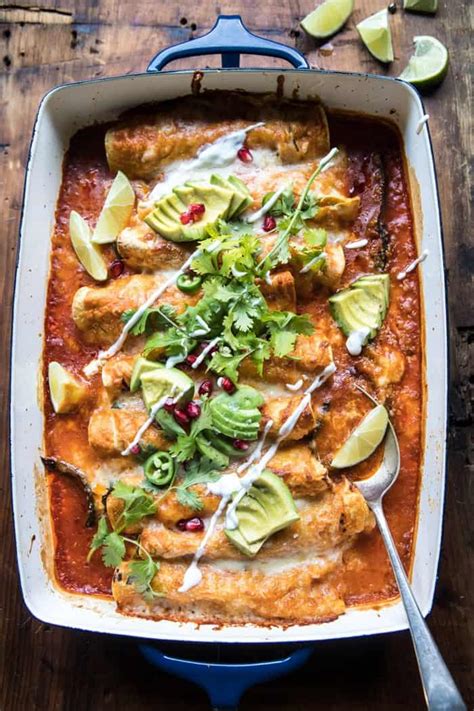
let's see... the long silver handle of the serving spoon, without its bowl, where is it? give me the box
[369,501,466,711]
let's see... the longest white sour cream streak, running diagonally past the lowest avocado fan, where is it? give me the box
[179,363,336,592]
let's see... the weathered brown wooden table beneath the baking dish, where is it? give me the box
[0,0,474,711]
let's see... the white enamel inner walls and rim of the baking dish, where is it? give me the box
[11,70,447,642]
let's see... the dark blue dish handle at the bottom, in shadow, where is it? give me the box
[140,644,313,711]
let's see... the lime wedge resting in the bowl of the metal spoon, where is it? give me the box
[331,405,388,469]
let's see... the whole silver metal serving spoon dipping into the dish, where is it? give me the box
[354,418,466,711]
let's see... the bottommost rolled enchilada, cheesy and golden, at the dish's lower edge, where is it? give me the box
[112,560,345,624]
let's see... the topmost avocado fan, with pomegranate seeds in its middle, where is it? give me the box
[145,175,252,242]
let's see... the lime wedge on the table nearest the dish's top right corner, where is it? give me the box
[400,35,448,89]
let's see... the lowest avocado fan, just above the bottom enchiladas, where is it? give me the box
[225,470,299,556]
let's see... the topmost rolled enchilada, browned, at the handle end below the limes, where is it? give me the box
[105,93,329,179]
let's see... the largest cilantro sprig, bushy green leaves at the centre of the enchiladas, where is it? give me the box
[144,231,313,382]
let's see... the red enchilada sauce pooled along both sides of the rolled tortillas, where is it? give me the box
[44,115,423,605]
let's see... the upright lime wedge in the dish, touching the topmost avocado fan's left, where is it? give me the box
[92,170,135,244]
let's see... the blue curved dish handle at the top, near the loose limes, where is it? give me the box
[147,15,309,72]
